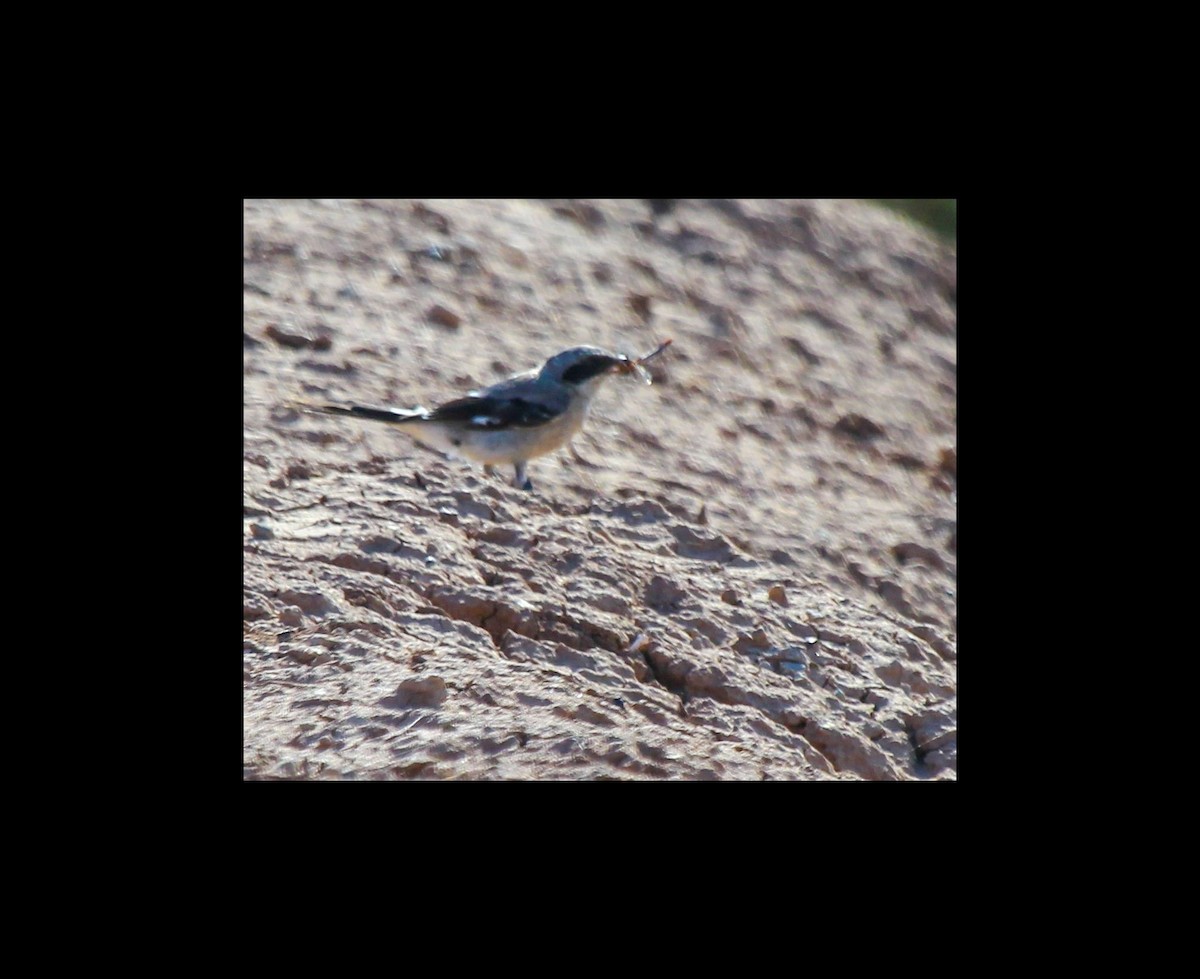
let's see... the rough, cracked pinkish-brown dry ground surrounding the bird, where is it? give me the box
[242,200,958,780]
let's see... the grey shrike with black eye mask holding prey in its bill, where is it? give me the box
[304,340,671,490]
